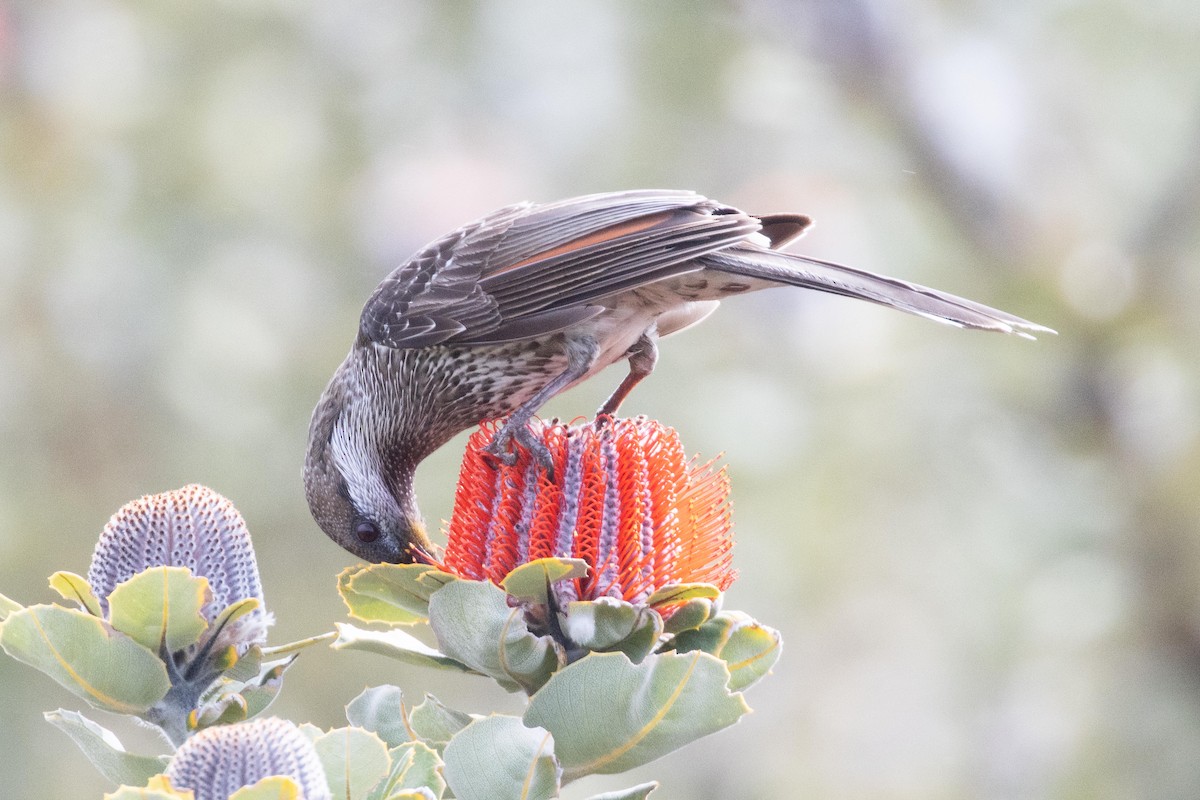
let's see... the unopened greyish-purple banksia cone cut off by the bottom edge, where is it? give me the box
[167,717,331,800]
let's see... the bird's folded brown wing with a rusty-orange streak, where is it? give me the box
[360,191,761,348]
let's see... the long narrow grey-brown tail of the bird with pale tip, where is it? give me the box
[701,247,1055,338]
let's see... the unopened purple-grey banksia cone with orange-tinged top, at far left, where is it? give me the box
[88,483,271,654]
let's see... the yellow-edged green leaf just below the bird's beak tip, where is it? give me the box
[337,564,455,625]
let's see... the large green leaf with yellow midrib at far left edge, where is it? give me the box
[0,606,170,714]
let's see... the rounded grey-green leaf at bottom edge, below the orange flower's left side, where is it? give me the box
[443,716,560,800]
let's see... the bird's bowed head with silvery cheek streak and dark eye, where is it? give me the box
[305,378,434,564]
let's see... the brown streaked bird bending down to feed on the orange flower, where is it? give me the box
[304,190,1054,564]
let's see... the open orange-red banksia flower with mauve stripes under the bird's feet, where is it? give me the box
[442,417,734,603]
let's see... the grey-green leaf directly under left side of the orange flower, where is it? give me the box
[430,581,558,691]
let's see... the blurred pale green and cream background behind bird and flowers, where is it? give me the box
[0,0,1200,800]
